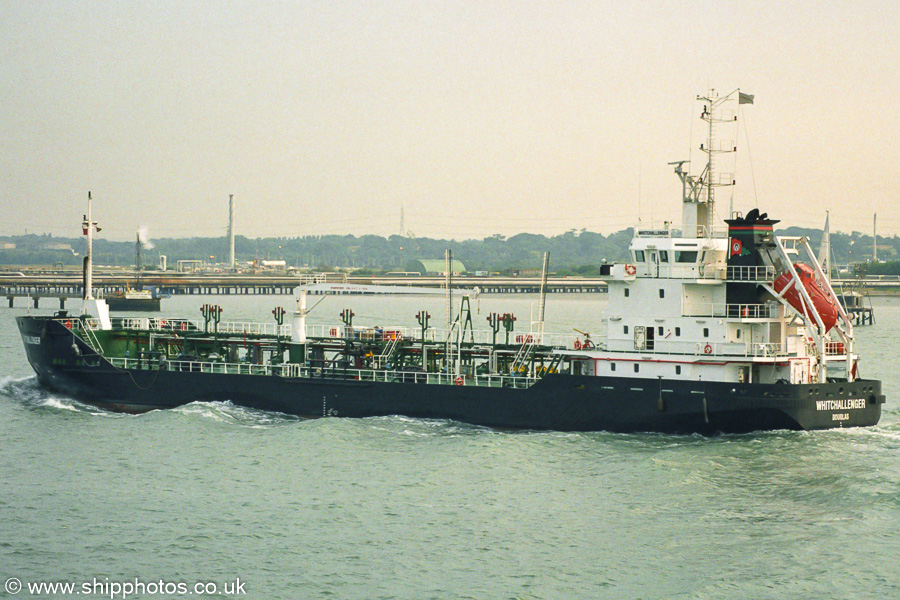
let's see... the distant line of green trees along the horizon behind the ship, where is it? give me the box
[0,227,900,275]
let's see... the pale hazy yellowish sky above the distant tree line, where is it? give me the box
[0,0,900,239]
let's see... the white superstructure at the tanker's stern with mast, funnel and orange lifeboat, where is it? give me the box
[567,90,857,383]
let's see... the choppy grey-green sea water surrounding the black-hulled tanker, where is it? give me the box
[0,295,900,600]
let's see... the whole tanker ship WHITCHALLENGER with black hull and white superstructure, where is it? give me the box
[17,90,885,434]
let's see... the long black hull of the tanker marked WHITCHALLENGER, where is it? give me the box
[17,317,884,434]
